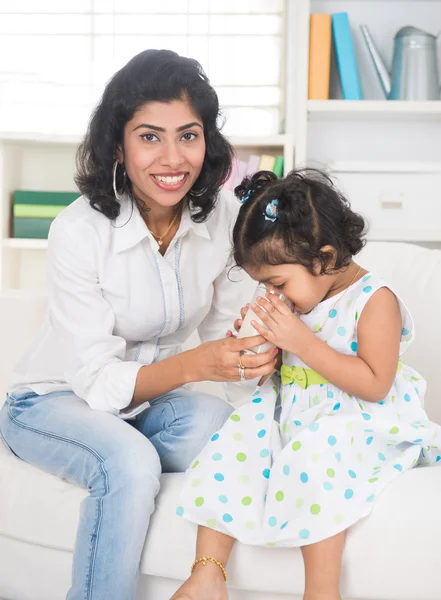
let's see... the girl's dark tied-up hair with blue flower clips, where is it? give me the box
[233,169,366,274]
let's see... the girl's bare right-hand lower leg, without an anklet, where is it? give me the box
[302,531,346,600]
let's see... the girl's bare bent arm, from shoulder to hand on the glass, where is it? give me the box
[249,288,402,402]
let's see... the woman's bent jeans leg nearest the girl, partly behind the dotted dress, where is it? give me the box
[134,388,233,473]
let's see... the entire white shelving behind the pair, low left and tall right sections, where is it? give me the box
[0,0,441,289]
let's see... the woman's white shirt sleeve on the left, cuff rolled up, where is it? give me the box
[47,219,148,418]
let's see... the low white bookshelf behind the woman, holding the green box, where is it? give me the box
[0,132,294,290]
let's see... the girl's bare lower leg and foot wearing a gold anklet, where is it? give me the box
[171,526,235,600]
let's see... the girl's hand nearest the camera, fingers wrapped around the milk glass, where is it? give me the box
[251,293,315,356]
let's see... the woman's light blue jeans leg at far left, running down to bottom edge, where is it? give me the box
[0,393,160,600]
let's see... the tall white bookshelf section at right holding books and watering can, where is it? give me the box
[290,0,441,247]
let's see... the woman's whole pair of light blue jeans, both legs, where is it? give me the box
[0,388,231,600]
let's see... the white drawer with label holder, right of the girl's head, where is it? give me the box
[328,163,441,242]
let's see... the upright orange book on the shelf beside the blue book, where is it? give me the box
[308,14,332,100]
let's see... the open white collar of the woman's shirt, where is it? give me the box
[112,194,211,252]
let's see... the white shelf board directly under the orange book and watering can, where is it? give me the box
[307,100,441,121]
